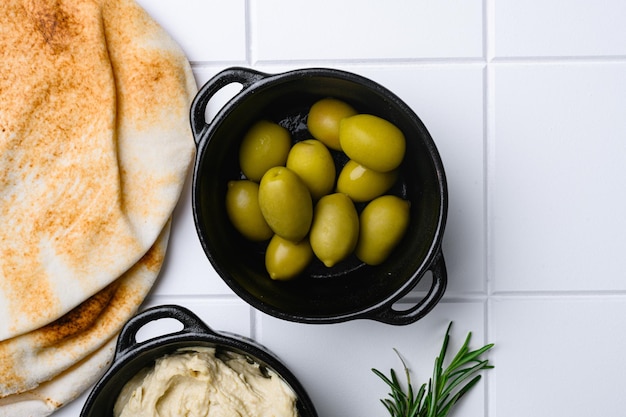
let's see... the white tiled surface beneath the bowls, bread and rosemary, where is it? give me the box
[18,0,626,417]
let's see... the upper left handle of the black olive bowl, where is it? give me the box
[190,67,269,144]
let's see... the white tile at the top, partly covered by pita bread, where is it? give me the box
[137,0,247,62]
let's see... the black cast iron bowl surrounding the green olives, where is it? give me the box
[191,67,448,325]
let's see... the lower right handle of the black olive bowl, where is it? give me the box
[367,249,448,325]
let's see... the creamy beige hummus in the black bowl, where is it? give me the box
[114,347,298,417]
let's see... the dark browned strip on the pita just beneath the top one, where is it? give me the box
[38,281,119,346]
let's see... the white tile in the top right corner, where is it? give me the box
[493,0,626,57]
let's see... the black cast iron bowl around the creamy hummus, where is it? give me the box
[80,305,317,417]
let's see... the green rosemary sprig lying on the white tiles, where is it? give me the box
[372,322,494,417]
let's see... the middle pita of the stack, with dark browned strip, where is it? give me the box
[0,223,170,400]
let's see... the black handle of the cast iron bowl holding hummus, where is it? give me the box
[114,305,216,361]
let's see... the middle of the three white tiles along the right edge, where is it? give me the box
[490,63,626,291]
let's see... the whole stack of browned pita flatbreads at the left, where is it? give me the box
[0,0,196,417]
